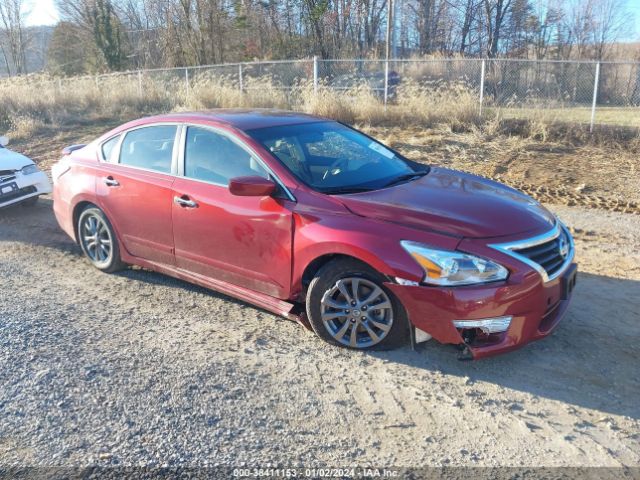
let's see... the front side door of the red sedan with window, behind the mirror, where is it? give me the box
[173,126,294,298]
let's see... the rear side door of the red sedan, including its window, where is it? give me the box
[96,124,178,265]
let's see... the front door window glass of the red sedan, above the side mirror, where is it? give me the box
[184,127,269,185]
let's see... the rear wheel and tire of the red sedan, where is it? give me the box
[78,207,125,273]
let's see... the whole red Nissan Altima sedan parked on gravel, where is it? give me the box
[52,110,576,359]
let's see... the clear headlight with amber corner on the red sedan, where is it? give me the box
[400,240,509,286]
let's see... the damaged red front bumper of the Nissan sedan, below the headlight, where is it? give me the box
[387,264,576,359]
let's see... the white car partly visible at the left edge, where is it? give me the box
[0,137,51,208]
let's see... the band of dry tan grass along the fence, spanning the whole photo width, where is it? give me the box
[0,75,640,144]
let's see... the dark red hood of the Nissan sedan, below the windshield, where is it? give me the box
[339,167,555,238]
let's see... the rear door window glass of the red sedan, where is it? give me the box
[120,125,177,173]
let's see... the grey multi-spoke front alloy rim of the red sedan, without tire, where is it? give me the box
[321,277,393,348]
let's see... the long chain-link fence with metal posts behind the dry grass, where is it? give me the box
[6,58,640,128]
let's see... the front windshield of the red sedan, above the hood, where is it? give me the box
[247,122,427,193]
